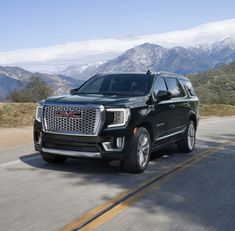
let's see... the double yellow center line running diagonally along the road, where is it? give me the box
[61,141,235,231]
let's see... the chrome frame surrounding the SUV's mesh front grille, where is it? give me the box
[42,103,105,137]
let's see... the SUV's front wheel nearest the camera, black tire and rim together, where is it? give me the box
[121,127,151,173]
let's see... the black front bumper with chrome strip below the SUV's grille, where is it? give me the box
[34,121,133,159]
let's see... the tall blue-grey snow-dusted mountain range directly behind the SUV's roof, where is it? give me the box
[61,37,235,80]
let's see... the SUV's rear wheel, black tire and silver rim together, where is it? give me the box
[178,120,196,153]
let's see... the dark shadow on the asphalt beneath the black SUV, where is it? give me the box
[20,134,231,177]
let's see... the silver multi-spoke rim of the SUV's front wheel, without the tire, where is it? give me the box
[137,133,150,168]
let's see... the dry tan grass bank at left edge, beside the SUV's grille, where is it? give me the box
[0,103,36,128]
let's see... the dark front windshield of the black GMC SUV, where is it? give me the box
[77,74,153,96]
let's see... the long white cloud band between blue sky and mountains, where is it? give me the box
[0,19,235,70]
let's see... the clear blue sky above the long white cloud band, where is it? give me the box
[0,0,235,51]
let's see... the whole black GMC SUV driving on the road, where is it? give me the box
[34,71,199,173]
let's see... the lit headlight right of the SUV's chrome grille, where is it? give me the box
[106,108,130,127]
